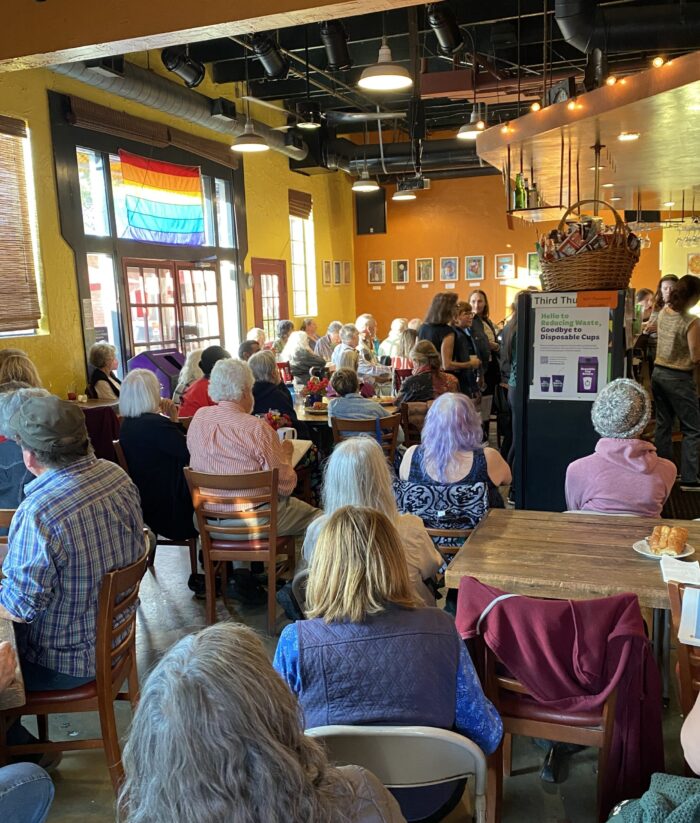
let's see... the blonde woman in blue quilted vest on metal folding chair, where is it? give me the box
[273,506,503,820]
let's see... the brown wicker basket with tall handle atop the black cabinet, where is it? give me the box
[540,200,639,291]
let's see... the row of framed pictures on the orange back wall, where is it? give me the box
[367,252,540,286]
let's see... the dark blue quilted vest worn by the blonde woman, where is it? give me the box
[296,608,462,729]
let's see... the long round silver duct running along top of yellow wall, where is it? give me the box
[52,63,308,160]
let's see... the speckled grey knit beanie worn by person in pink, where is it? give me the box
[591,377,651,439]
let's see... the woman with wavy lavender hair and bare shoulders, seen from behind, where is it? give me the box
[394,394,511,549]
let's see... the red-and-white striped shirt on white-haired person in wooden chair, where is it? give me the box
[187,400,297,511]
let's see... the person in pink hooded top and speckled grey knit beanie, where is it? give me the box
[565,378,676,517]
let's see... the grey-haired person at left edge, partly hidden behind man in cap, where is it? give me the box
[0,381,48,534]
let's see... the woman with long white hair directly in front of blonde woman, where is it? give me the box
[302,437,442,606]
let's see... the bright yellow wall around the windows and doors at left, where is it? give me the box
[0,62,355,395]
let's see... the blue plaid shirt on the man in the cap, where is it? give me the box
[0,456,145,677]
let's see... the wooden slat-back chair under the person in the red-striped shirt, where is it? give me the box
[185,468,295,634]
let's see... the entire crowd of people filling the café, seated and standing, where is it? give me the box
[0,282,700,823]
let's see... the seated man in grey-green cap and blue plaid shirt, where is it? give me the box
[0,395,145,691]
